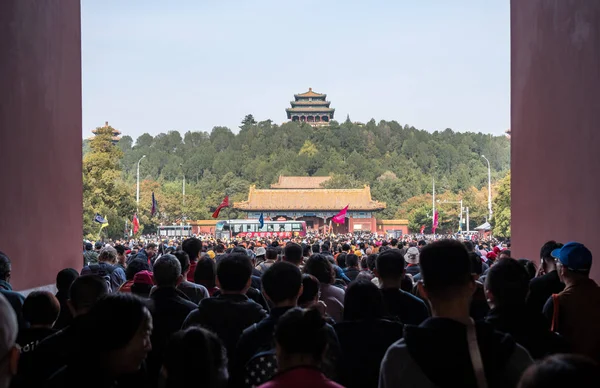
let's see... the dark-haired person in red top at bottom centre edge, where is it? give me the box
[260,307,341,388]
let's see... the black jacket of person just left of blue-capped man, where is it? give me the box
[485,306,568,359]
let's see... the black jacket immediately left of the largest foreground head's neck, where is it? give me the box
[381,288,429,325]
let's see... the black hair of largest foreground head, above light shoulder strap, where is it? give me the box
[418,240,473,294]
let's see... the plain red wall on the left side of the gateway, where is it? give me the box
[0,0,82,290]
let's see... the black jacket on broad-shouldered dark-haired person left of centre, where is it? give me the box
[183,294,267,359]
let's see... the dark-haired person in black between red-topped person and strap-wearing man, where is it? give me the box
[334,280,404,388]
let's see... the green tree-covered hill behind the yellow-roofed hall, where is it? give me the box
[84,115,510,234]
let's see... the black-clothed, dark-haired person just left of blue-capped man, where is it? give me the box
[485,259,568,359]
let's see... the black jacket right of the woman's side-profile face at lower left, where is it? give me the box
[147,287,197,379]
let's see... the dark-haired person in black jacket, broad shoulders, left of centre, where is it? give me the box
[182,252,267,357]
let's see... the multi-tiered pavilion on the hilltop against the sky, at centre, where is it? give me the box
[285,88,335,126]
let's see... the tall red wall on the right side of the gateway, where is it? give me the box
[511,0,600,280]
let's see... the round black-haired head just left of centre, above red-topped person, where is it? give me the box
[261,261,302,303]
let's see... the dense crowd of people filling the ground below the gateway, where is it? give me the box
[0,235,600,388]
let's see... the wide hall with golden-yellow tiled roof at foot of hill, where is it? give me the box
[233,176,385,233]
